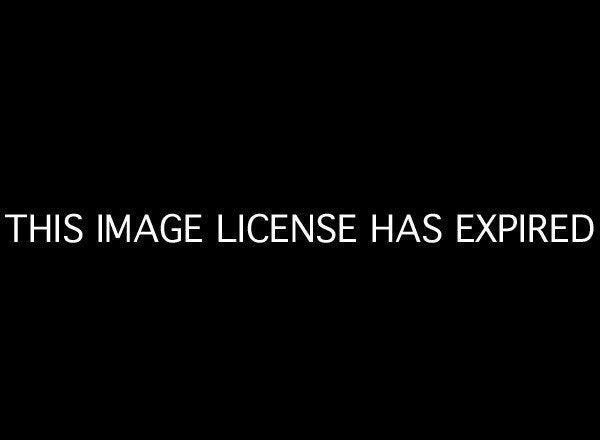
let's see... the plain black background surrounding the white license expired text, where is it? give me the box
[1,5,598,433]
